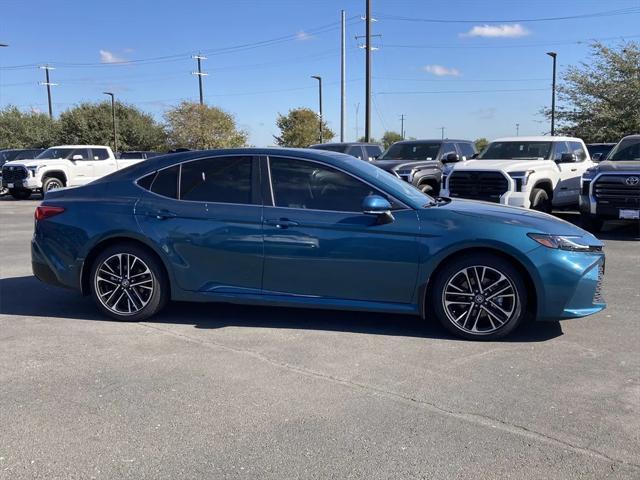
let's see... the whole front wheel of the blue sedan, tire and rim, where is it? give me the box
[431,253,527,340]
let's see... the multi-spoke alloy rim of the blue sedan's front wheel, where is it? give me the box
[442,265,519,335]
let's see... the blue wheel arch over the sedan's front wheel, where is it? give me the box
[419,245,540,318]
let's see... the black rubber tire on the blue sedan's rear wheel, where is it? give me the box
[89,243,170,322]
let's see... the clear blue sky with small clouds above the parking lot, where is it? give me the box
[0,0,640,145]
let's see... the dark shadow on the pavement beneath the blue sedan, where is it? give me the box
[0,276,562,342]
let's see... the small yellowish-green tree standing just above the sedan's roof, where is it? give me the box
[273,108,335,148]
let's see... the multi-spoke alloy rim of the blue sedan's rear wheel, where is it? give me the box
[94,253,156,316]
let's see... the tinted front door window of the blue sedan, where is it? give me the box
[269,157,379,212]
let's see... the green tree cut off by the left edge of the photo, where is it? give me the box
[0,106,58,148]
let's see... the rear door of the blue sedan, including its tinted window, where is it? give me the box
[136,155,263,295]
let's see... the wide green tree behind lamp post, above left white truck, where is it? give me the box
[57,101,166,151]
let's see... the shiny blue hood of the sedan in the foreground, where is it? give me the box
[420,199,602,246]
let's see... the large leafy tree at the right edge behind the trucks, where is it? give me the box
[543,42,640,143]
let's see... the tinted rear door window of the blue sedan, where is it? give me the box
[180,157,252,204]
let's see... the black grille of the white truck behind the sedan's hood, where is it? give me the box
[449,170,509,202]
